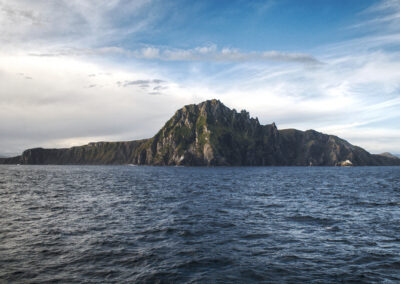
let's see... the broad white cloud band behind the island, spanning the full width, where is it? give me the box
[0,43,400,155]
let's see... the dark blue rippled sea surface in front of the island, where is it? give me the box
[0,166,400,283]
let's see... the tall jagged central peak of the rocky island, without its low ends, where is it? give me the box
[138,100,281,166]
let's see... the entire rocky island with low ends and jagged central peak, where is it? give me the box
[0,100,400,166]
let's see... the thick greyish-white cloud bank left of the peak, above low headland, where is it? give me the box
[0,53,193,153]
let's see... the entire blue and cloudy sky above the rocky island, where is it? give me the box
[0,0,400,156]
